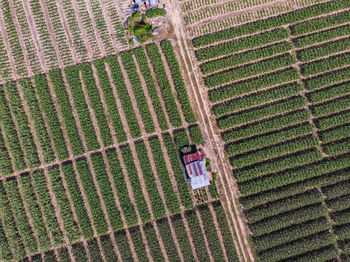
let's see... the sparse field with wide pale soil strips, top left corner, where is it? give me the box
[0,0,128,83]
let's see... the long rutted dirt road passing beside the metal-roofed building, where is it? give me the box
[166,0,254,261]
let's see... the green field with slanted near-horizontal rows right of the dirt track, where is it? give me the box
[190,0,350,262]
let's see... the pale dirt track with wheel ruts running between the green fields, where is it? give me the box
[167,0,254,261]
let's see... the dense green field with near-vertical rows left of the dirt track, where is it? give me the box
[0,35,237,262]
